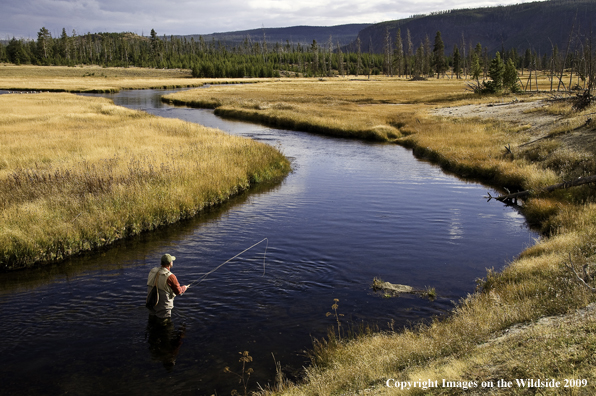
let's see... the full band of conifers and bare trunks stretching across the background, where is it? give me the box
[0,27,596,92]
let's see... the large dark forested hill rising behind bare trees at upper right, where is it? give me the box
[348,0,596,54]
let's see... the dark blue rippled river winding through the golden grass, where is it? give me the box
[0,90,537,395]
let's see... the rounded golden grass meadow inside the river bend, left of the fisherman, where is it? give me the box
[0,93,289,269]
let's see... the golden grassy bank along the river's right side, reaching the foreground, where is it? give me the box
[167,79,596,395]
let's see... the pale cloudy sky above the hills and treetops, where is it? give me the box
[0,0,526,40]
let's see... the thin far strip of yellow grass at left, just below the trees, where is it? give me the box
[0,64,262,93]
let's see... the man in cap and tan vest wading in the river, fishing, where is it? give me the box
[147,254,188,320]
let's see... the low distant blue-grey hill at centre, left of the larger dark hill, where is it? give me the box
[180,24,370,47]
